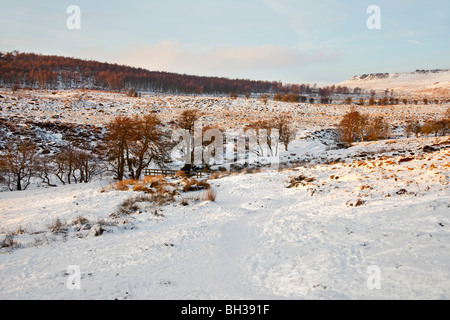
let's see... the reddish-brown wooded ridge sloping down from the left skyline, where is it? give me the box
[0,51,289,94]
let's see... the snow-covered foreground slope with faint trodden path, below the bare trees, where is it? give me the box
[0,133,450,299]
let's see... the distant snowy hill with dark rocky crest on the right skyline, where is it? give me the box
[339,69,450,96]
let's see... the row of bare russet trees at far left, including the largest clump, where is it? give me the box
[0,114,178,191]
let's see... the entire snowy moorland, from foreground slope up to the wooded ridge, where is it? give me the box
[0,88,450,299]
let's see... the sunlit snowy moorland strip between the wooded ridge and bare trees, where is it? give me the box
[0,89,449,130]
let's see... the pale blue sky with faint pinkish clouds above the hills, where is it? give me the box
[0,0,450,85]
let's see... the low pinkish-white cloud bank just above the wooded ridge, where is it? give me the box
[79,40,339,78]
